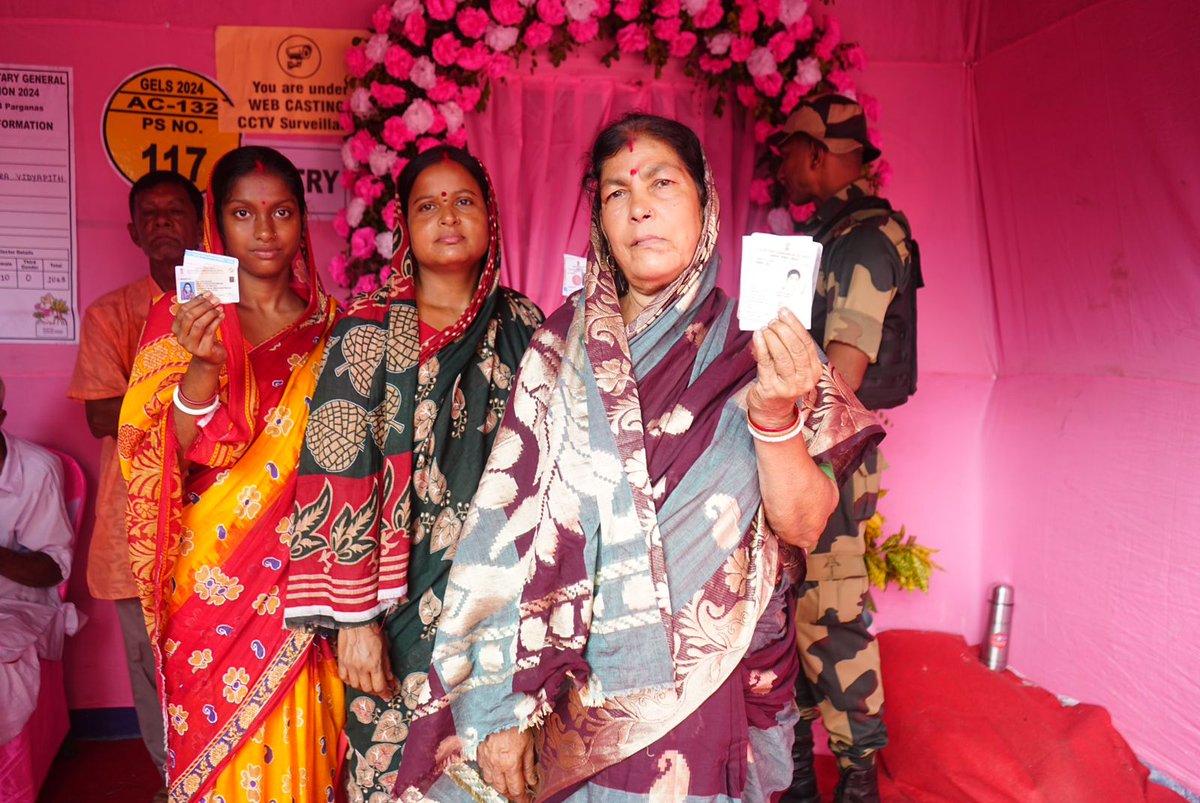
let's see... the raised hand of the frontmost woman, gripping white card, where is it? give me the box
[746,308,822,429]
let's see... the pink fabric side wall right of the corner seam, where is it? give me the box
[976,0,1200,789]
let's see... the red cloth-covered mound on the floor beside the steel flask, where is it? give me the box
[868,630,1183,803]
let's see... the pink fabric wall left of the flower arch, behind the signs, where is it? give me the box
[0,17,350,708]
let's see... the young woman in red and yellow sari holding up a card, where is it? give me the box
[118,148,344,803]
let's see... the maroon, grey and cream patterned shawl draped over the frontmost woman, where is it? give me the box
[396,160,882,801]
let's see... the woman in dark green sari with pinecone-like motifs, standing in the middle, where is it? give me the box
[284,146,541,803]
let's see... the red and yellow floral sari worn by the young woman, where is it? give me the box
[118,205,344,803]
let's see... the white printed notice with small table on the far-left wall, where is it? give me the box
[0,65,78,343]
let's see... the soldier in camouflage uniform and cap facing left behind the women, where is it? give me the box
[772,95,919,803]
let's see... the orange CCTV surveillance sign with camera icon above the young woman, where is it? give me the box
[216,25,367,137]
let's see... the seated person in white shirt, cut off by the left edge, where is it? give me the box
[0,379,80,745]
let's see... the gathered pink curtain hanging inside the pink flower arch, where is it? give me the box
[467,48,754,312]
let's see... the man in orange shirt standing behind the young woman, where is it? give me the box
[67,170,204,787]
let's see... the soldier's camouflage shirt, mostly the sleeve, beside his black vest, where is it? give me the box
[803,180,908,362]
